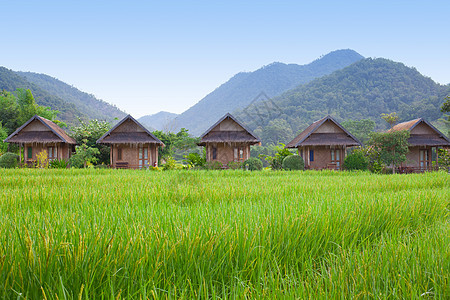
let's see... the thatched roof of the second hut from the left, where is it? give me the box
[97,115,164,146]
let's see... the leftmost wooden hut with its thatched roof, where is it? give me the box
[5,115,77,165]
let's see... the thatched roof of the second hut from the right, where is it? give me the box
[286,116,362,148]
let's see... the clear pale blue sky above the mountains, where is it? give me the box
[0,0,450,117]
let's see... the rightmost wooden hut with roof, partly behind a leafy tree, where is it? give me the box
[389,118,450,171]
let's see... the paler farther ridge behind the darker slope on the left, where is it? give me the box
[17,72,126,121]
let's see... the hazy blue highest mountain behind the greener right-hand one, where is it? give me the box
[167,50,363,135]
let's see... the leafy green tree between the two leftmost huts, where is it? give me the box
[71,119,111,165]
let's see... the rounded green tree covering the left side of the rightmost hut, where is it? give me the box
[369,130,410,173]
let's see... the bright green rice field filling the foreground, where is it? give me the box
[0,169,450,299]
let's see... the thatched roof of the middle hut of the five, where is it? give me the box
[198,113,261,146]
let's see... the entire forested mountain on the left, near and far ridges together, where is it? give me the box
[0,67,126,125]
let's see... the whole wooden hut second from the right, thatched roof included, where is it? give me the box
[286,116,362,170]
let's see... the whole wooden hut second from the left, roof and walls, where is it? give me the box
[97,115,164,169]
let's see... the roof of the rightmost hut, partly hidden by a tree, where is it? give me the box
[388,118,450,147]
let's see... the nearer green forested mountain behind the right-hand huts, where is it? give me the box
[237,58,450,143]
